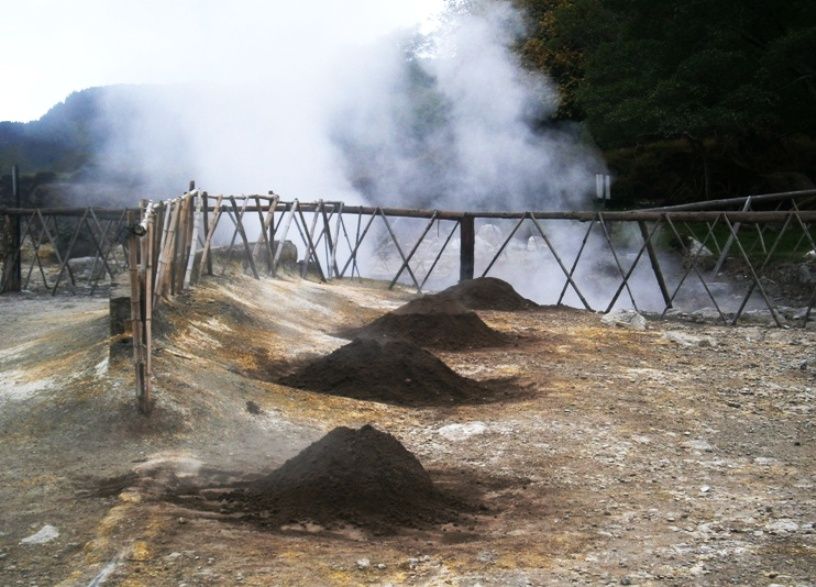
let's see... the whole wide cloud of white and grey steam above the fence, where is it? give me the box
[91,3,603,209]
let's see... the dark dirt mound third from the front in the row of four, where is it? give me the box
[342,296,508,350]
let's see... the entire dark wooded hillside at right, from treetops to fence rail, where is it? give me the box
[516,0,816,201]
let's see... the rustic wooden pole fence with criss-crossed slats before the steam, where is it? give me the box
[0,185,816,413]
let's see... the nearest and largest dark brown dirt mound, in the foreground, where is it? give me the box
[223,426,455,532]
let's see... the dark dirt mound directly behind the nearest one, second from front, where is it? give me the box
[280,338,485,406]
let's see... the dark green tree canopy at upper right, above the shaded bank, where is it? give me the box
[517,0,816,147]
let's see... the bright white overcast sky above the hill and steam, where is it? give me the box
[0,0,444,121]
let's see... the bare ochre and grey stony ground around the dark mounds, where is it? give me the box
[0,278,816,586]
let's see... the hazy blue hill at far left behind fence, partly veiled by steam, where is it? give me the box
[0,85,192,206]
